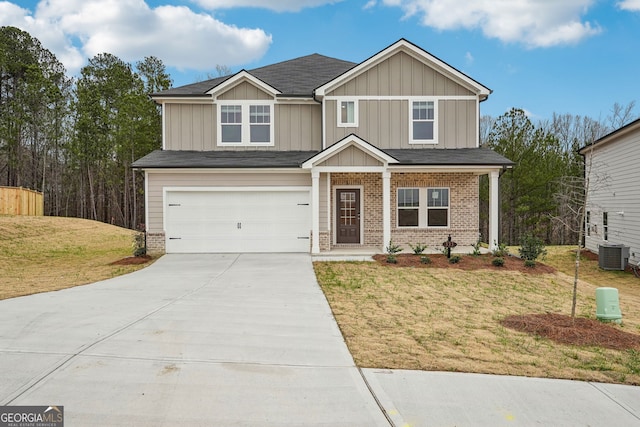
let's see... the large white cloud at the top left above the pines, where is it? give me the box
[0,0,271,74]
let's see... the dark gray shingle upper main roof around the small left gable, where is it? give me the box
[152,53,357,96]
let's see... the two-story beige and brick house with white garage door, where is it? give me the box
[133,39,512,253]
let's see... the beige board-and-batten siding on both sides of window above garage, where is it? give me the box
[164,103,322,151]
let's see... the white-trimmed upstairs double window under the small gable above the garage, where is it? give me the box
[218,101,274,145]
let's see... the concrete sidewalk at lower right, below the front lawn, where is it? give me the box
[363,369,640,427]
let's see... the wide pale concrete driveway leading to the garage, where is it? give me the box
[0,254,389,426]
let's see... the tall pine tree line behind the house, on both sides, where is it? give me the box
[0,27,635,245]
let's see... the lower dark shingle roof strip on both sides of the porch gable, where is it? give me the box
[132,148,513,169]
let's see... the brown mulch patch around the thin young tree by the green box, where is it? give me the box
[501,313,640,350]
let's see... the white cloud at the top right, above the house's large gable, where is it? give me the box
[383,0,604,47]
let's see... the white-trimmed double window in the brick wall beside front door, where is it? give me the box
[397,187,450,228]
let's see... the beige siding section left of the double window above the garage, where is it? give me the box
[164,104,215,151]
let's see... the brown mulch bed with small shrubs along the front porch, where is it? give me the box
[373,254,556,274]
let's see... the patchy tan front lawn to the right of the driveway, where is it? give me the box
[314,247,640,385]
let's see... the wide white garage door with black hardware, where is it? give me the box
[165,189,311,253]
